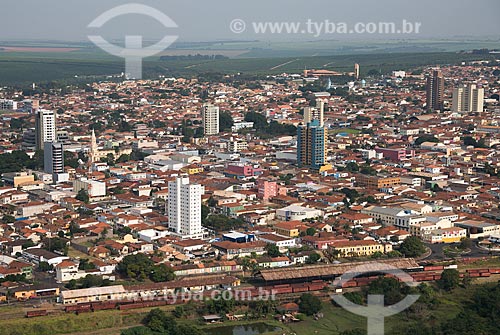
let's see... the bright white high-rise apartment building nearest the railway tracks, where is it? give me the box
[167,175,205,239]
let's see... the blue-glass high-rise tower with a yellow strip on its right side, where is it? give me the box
[297,119,328,170]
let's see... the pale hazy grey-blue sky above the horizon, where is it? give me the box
[0,0,500,41]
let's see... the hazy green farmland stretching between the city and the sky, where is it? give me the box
[0,42,500,87]
